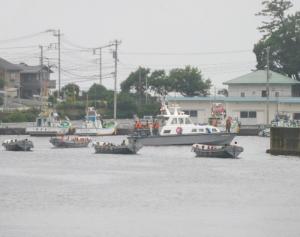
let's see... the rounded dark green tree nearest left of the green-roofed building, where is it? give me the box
[169,66,211,96]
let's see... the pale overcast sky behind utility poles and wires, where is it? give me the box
[0,0,300,89]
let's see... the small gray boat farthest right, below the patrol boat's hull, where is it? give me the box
[192,144,244,158]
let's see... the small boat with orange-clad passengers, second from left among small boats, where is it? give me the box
[50,136,91,148]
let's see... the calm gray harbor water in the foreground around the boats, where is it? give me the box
[0,136,300,237]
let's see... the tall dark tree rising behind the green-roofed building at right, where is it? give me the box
[253,0,300,80]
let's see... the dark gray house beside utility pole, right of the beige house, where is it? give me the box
[19,63,56,99]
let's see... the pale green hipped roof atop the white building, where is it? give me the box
[223,70,300,85]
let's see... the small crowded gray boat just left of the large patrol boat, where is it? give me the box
[94,139,143,154]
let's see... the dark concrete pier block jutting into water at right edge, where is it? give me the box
[269,127,300,156]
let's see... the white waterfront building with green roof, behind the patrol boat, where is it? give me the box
[167,70,300,125]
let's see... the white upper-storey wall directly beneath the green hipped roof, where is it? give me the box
[228,84,292,97]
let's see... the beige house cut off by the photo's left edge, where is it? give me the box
[0,58,22,98]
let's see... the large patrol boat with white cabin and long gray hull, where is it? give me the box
[128,103,236,146]
